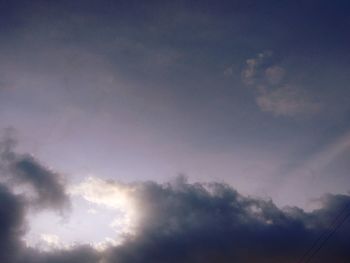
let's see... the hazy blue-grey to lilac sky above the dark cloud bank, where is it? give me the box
[0,0,350,262]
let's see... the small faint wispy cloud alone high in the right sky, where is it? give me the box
[242,51,321,117]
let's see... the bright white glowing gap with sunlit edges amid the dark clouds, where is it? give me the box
[25,177,137,251]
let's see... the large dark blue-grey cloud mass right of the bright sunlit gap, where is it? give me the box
[100,179,350,263]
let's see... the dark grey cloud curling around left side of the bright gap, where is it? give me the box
[0,134,99,263]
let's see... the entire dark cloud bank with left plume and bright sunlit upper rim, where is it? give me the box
[0,136,350,263]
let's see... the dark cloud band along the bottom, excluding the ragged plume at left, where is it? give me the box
[0,165,350,263]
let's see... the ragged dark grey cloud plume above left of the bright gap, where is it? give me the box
[0,135,69,211]
